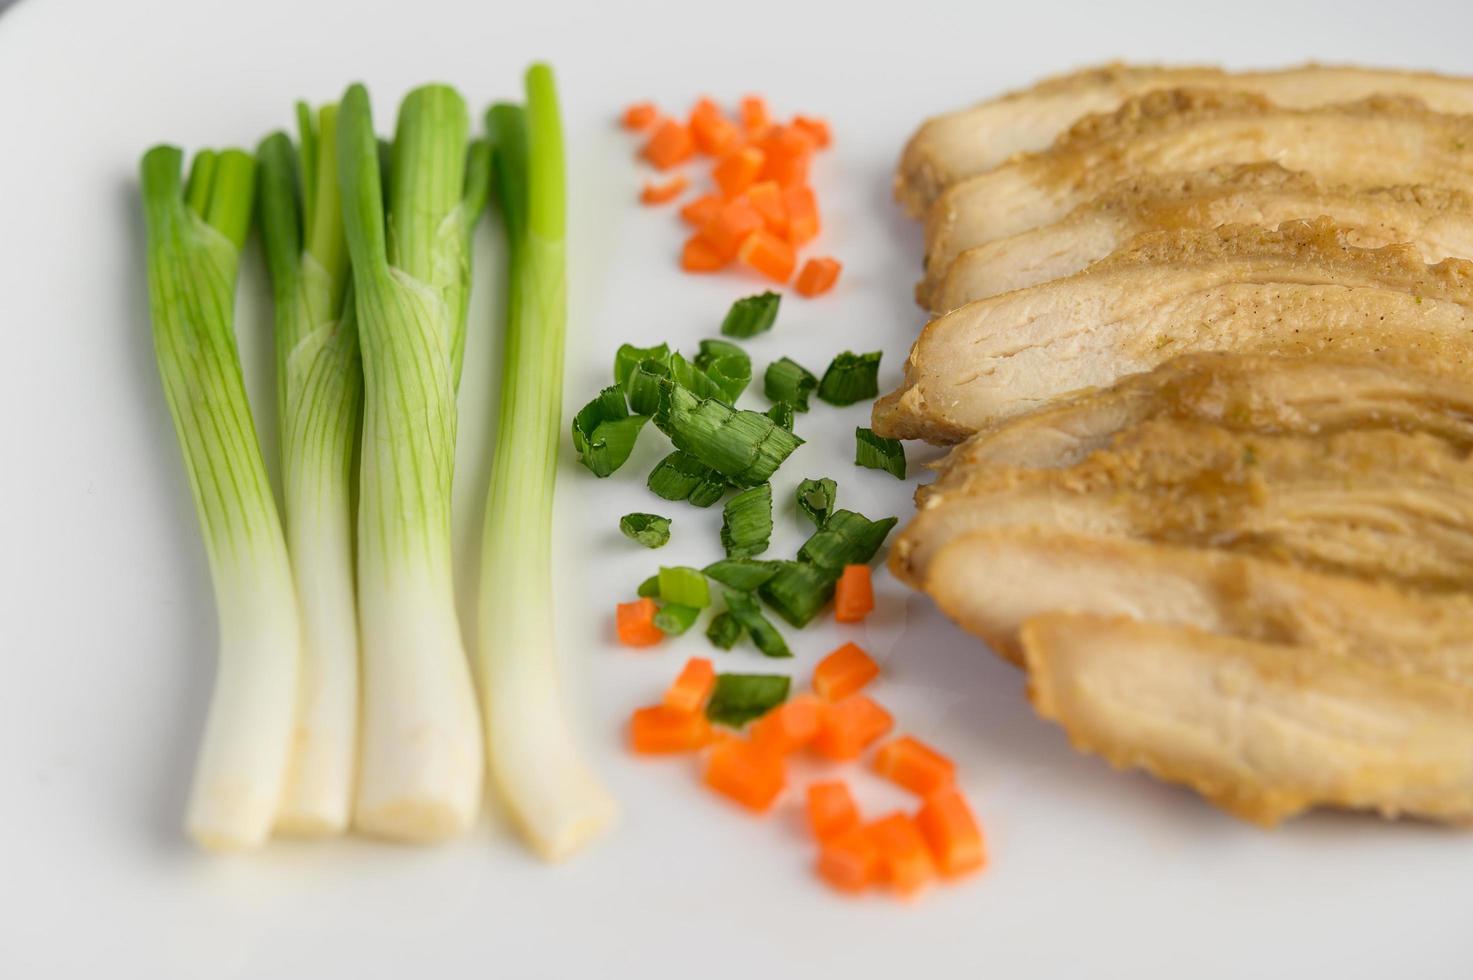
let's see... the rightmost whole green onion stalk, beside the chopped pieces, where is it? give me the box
[477,65,617,859]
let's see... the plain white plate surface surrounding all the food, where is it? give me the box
[0,0,1473,980]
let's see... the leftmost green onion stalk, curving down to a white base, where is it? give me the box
[140,146,300,847]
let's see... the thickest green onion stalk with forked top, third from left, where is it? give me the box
[337,85,489,840]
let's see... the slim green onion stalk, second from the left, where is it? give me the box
[256,105,362,836]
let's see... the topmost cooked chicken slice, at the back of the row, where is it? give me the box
[896,65,1473,218]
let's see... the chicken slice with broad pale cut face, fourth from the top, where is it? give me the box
[873,220,1473,442]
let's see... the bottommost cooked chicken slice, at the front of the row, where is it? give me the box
[1022,613,1473,827]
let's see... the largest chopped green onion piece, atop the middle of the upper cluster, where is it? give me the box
[666,385,803,486]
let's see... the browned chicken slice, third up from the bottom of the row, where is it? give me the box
[891,419,1473,592]
